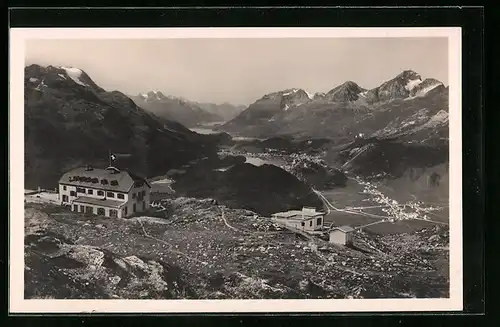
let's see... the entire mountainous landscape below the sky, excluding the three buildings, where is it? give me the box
[25,65,449,299]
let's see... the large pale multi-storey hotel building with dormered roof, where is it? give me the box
[59,167,151,218]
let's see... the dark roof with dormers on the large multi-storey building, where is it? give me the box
[59,167,151,192]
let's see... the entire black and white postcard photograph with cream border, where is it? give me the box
[10,28,462,312]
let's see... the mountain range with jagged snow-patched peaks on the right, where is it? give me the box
[219,70,448,141]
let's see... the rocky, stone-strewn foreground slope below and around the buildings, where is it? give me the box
[25,202,449,299]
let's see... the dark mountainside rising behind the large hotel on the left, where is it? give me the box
[24,65,214,187]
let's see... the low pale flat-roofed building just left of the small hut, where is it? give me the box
[271,207,325,231]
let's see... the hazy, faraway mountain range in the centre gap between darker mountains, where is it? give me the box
[130,91,244,127]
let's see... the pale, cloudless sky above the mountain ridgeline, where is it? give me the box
[25,37,448,105]
